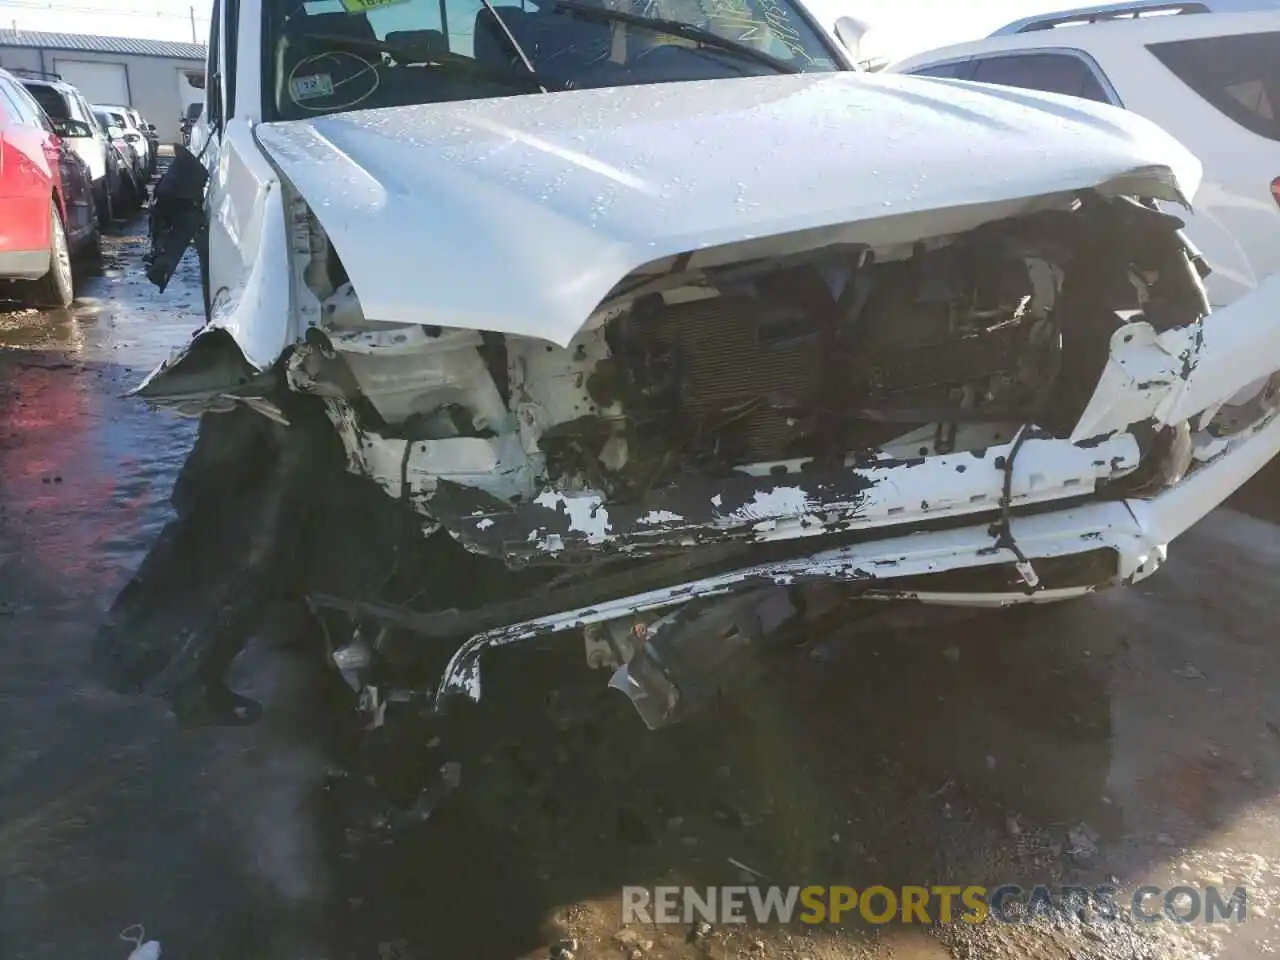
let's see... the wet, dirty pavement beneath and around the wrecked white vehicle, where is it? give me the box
[0,220,1280,960]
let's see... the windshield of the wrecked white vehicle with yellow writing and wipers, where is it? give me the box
[268,0,840,119]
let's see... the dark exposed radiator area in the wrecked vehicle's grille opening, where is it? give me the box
[544,227,1062,498]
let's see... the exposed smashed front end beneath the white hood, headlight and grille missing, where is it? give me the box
[289,193,1208,562]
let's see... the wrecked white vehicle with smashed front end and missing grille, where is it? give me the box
[120,0,1280,742]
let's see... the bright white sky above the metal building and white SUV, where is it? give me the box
[0,0,1074,59]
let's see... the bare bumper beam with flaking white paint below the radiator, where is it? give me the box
[431,434,1140,559]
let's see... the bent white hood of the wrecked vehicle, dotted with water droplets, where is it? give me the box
[256,73,1201,344]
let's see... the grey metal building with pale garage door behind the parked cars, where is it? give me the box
[0,29,205,143]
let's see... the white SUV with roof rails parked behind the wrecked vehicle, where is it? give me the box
[888,0,1280,306]
